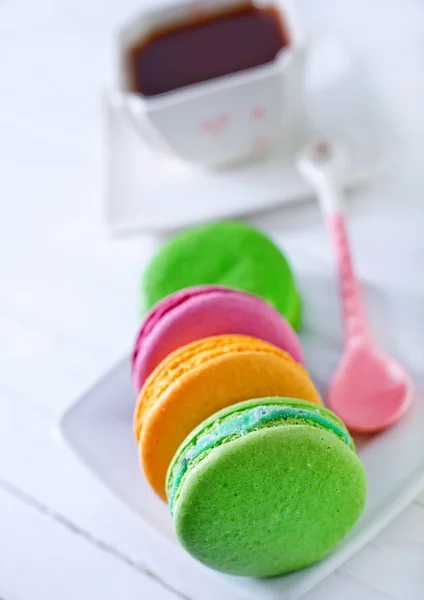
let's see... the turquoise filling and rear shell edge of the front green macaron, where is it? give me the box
[167,399,353,514]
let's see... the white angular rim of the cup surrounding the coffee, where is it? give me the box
[118,0,306,108]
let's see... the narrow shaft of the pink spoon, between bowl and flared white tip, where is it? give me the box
[317,176,369,346]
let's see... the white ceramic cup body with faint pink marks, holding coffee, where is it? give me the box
[118,0,306,167]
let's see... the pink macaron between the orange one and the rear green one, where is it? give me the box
[132,285,304,392]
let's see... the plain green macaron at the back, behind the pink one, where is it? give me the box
[141,221,301,329]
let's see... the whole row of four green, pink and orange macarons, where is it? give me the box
[132,223,366,577]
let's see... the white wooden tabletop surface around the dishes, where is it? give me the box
[0,0,424,600]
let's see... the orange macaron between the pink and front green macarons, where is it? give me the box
[134,335,321,499]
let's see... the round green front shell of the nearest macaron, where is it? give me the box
[174,425,366,577]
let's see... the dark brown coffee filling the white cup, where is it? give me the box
[125,2,290,96]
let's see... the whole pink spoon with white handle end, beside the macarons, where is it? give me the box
[299,142,413,433]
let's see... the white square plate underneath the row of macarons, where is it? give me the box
[59,275,424,600]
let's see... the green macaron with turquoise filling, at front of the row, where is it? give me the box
[167,398,366,577]
